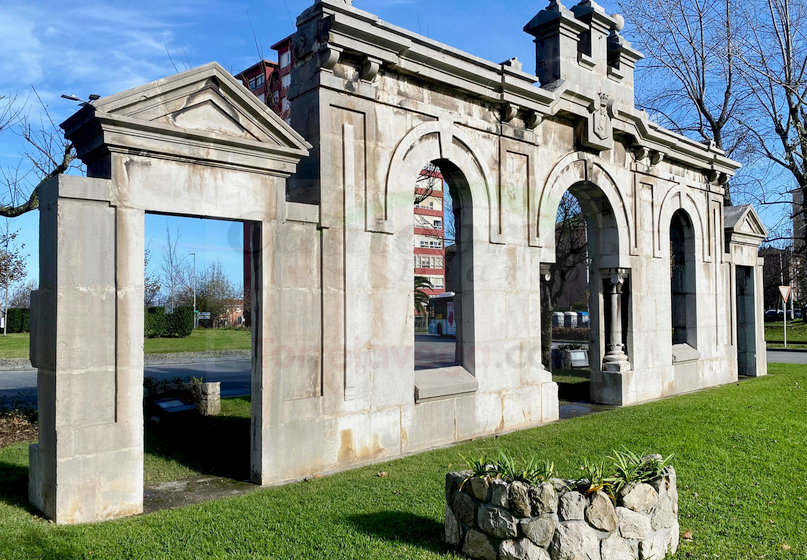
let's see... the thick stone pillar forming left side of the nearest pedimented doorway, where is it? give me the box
[28,175,144,524]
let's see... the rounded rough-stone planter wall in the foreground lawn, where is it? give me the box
[445,466,679,560]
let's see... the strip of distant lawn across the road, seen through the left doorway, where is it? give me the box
[0,329,252,358]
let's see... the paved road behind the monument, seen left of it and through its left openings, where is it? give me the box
[0,334,456,402]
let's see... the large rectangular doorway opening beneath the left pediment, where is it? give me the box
[143,214,254,490]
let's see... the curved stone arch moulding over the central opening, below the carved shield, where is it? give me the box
[536,152,634,267]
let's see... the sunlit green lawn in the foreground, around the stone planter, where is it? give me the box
[0,365,807,560]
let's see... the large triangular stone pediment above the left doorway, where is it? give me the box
[62,62,309,155]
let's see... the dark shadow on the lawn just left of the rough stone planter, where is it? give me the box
[348,511,446,553]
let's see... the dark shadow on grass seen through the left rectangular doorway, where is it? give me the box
[145,397,250,480]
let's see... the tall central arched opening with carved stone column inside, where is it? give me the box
[541,181,630,402]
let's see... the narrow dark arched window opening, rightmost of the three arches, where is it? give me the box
[670,210,698,348]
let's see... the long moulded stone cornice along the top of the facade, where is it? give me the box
[297,0,740,176]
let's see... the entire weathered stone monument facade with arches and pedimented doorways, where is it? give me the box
[30,0,766,523]
